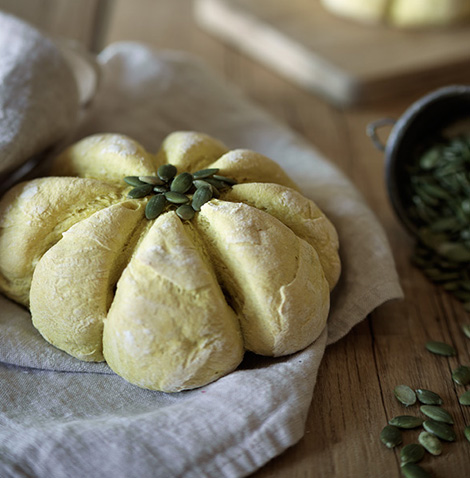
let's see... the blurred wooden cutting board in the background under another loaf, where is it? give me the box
[194,0,470,105]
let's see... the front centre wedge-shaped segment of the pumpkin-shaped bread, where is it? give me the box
[103,212,244,392]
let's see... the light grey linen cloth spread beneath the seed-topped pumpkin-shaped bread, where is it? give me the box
[0,14,402,478]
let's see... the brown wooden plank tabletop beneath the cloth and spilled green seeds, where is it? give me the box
[4,0,470,478]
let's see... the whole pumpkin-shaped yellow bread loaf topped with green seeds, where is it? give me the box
[0,132,340,392]
